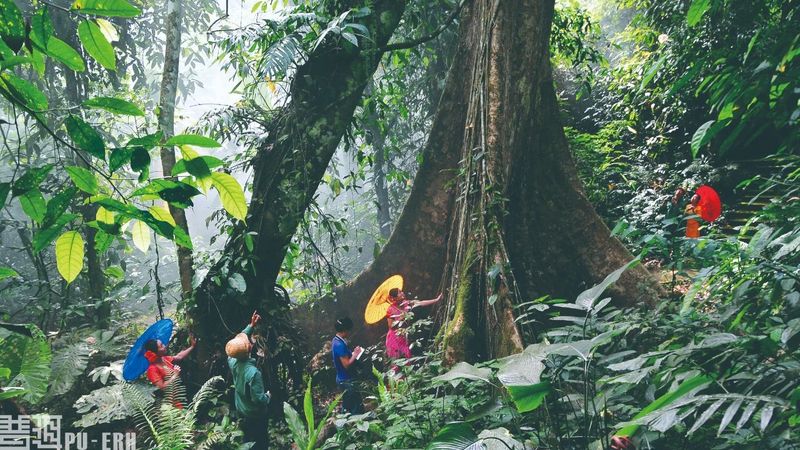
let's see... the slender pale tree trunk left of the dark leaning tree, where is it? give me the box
[158,0,194,298]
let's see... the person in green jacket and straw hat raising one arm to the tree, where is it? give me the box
[225,311,270,450]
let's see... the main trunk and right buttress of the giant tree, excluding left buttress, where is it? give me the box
[444,0,659,362]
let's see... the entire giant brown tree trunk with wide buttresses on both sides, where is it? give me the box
[298,0,658,361]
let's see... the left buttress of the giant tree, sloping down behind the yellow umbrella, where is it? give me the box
[293,5,476,349]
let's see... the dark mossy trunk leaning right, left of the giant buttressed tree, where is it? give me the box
[188,0,405,405]
